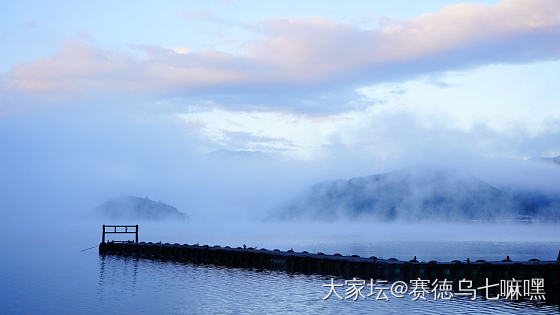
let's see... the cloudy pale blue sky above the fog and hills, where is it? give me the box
[0,0,560,222]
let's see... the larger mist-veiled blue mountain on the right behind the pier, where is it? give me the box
[274,169,558,221]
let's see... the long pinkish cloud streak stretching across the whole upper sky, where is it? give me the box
[0,0,560,108]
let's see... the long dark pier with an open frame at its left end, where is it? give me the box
[99,226,560,301]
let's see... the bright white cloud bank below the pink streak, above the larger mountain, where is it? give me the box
[180,62,560,160]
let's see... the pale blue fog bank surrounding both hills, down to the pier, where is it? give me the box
[0,108,560,249]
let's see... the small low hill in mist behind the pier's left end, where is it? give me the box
[94,196,188,221]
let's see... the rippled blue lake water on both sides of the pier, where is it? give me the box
[0,238,560,314]
